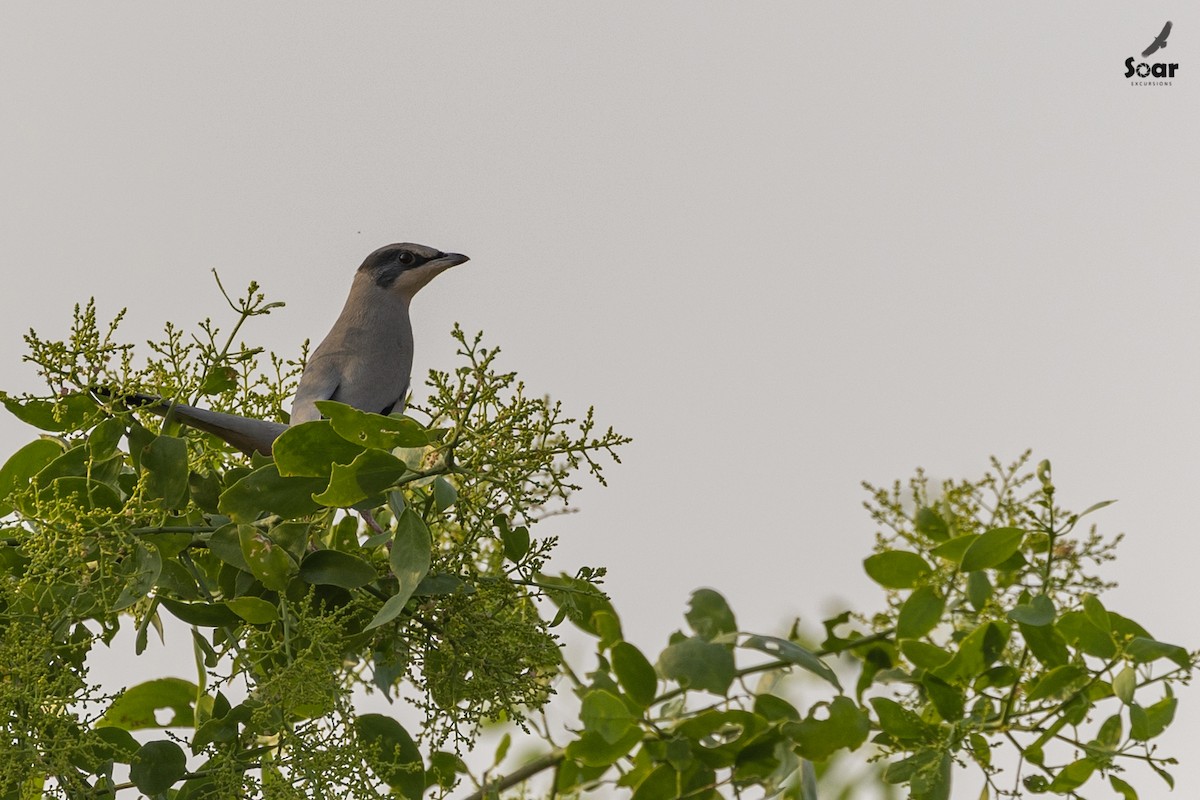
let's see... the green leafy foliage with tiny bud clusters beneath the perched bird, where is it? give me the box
[0,285,1196,800]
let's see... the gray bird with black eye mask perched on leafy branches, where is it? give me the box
[112,243,468,455]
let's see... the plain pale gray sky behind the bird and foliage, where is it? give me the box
[0,2,1200,796]
